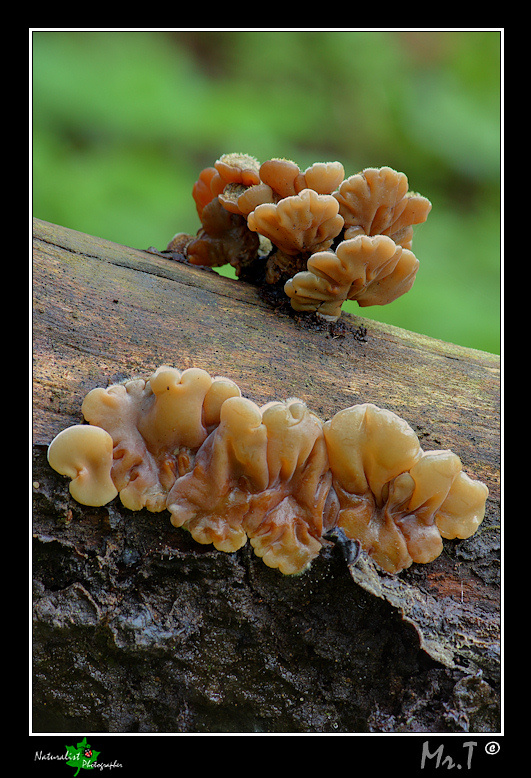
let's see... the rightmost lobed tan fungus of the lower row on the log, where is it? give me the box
[324,403,488,573]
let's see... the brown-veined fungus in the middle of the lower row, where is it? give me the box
[168,398,330,573]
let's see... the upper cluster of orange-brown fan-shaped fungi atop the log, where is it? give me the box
[167,154,431,320]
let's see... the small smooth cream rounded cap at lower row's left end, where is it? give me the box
[48,424,118,506]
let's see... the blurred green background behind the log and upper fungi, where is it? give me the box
[32,30,501,353]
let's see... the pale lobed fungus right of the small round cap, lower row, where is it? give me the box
[81,367,240,511]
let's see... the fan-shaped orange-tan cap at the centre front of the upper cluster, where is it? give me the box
[247,189,343,255]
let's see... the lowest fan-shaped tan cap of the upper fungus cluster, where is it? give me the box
[284,235,419,321]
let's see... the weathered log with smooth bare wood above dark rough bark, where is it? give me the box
[33,220,500,733]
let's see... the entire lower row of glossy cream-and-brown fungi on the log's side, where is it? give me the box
[48,366,488,575]
